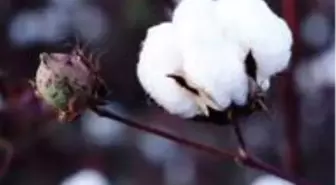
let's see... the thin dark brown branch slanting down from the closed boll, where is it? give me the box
[92,107,313,185]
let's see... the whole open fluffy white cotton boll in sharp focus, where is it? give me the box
[137,0,293,123]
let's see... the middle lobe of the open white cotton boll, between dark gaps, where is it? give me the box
[173,0,248,109]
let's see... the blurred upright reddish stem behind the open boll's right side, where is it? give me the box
[281,0,301,175]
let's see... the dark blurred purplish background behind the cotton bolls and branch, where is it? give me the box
[0,0,336,185]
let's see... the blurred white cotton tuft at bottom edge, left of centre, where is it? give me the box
[60,169,112,185]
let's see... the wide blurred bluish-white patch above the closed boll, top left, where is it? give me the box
[9,0,108,46]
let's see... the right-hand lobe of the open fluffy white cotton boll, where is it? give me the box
[216,0,293,90]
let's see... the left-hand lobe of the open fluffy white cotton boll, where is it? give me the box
[137,23,199,118]
